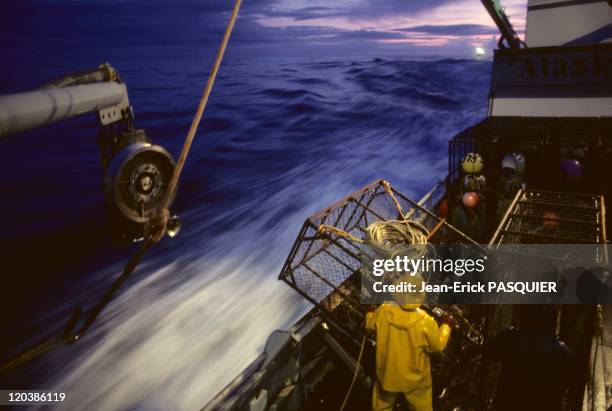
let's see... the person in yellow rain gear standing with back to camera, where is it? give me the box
[366,275,453,411]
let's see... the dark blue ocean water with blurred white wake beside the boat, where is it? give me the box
[0,49,490,410]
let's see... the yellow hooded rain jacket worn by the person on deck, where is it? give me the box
[366,304,451,393]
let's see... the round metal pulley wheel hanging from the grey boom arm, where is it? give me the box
[104,143,176,224]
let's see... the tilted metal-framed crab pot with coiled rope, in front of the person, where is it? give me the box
[279,180,487,409]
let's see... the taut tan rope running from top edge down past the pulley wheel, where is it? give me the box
[150,0,242,242]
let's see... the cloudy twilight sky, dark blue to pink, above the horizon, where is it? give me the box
[0,0,526,55]
